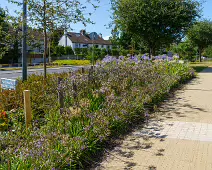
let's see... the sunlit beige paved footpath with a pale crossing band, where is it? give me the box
[96,68,212,170]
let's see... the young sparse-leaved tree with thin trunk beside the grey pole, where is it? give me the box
[9,0,99,78]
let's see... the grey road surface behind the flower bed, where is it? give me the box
[0,66,80,79]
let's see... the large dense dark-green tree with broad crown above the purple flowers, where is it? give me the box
[111,0,200,55]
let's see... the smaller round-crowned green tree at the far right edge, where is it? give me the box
[188,20,212,62]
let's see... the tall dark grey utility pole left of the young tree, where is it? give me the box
[22,0,27,81]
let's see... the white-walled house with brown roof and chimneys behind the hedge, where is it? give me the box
[59,30,112,50]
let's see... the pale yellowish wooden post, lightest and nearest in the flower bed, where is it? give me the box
[24,90,32,128]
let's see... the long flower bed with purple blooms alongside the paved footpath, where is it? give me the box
[0,57,194,169]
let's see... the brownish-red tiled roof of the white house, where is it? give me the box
[67,32,112,45]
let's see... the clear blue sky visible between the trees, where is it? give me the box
[0,0,212,37]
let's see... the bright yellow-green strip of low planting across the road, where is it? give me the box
[53,60,90,66]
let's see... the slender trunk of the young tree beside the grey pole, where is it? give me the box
[43,0,47,79]
